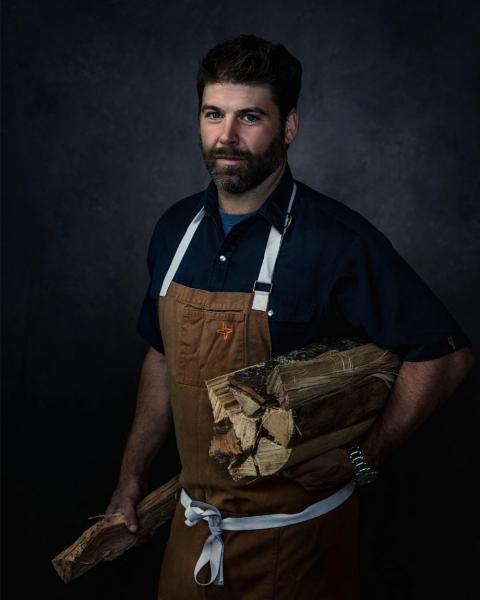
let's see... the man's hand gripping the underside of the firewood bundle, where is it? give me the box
[280,448,354,492]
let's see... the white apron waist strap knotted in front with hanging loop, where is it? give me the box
[180,481,355,585]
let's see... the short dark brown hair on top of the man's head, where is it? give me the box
[197,35,302,125]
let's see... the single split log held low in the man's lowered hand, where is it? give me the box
[52,476,178,583]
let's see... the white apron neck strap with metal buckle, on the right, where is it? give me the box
[252,182,297,311]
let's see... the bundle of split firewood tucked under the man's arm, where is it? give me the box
[206,338,401,480]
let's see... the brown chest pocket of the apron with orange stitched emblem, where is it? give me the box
[176,305,245,386]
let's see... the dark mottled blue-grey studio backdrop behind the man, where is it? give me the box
[3,0,480,600]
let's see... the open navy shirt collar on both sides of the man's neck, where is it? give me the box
[204,163,293,232]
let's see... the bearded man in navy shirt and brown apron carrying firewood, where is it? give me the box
[107,36,473,600]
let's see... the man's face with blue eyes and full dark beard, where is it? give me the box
[200,83,287,194]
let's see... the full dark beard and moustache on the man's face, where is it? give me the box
[200,135,287,194]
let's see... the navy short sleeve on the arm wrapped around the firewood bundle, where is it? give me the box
[334,231,472,361]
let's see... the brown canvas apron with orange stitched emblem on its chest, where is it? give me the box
[158,188,359,600]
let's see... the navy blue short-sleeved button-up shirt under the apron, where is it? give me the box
[138,165,471,361]
